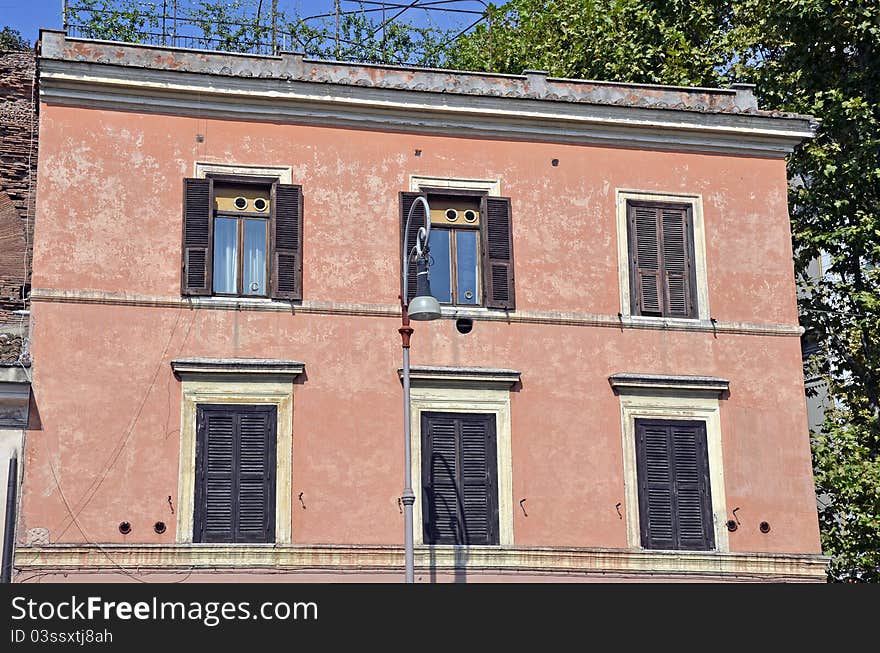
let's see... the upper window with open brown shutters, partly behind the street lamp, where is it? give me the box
[400,189,516,310]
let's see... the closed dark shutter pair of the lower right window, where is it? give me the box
[636,420,715,551]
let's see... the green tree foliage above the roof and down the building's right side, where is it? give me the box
[450,0,880,581]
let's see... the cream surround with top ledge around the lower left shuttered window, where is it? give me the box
[171,359,305,546]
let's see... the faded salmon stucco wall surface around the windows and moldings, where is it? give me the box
[19,106,819,553]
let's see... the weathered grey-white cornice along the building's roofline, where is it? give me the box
[40,31,816,157]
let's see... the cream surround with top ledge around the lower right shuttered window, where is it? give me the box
[609,374,730,555]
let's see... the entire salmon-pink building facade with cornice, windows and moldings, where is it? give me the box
[14,31,826,582]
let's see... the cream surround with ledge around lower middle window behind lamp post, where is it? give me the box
[398,366,520,547]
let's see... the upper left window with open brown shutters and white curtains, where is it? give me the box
[181,175,302,299]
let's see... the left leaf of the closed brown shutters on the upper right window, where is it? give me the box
[630,206,663,315]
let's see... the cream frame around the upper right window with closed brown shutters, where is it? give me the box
[615,188,711,324]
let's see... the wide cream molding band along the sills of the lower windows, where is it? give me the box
[13,544,828,582]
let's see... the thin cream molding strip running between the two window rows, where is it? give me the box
[31,288,804,338]
